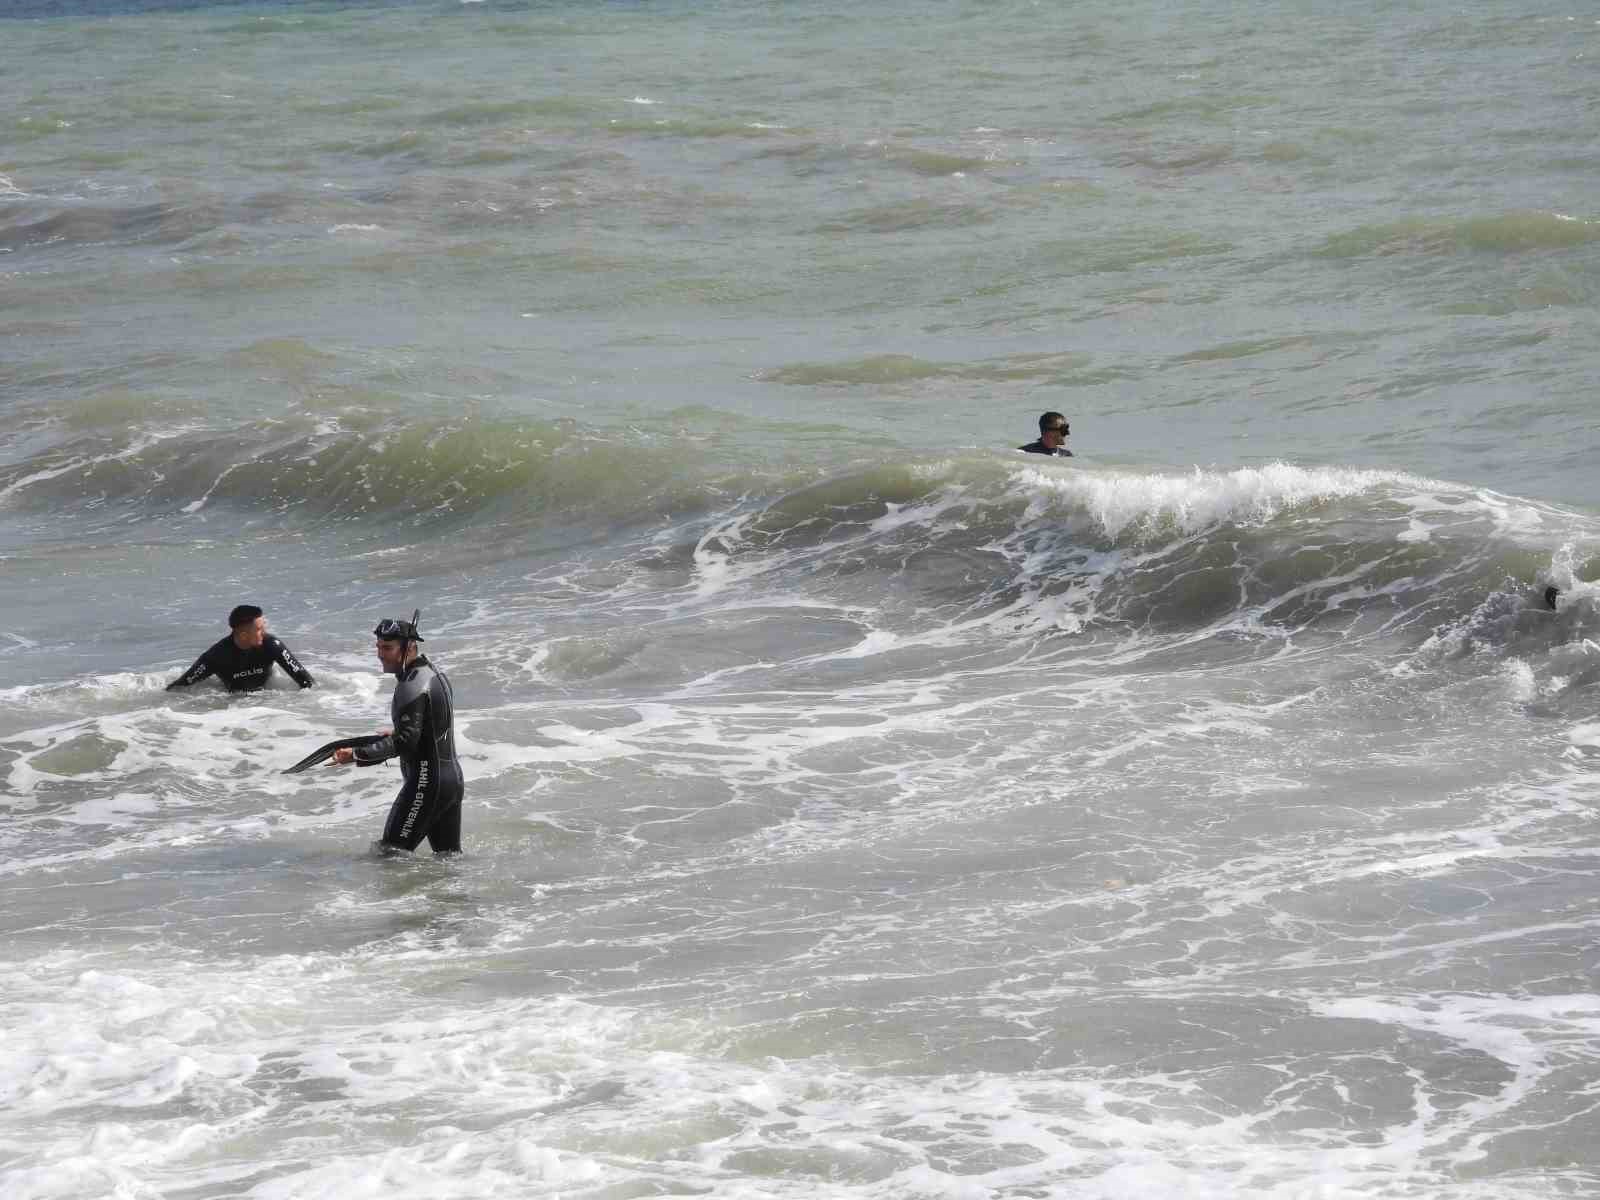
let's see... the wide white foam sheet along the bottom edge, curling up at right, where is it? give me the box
[9,952,1548,1200]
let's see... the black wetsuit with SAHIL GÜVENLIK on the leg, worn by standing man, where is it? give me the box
[355,654,466,854]
